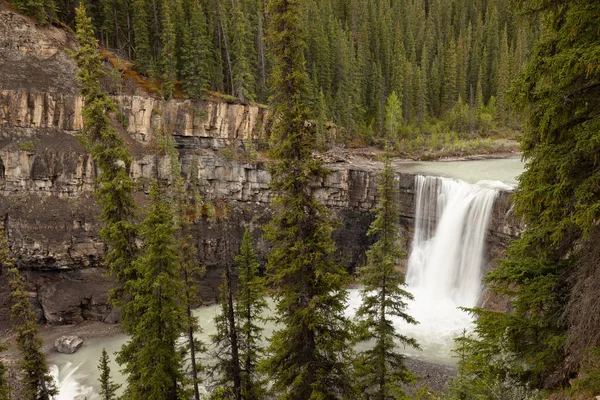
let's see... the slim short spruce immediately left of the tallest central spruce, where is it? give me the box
[235,229,267,400]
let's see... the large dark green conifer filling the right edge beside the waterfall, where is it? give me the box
[466,0,600,387]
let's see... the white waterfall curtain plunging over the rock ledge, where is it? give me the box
[406,175,498,307]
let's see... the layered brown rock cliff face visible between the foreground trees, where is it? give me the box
[0,3,519,323]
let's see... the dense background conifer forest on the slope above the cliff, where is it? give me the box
[12,0,536,147]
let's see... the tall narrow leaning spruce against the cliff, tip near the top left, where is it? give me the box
[73,4,137,318]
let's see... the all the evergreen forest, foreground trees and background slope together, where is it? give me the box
[0,0,600,400]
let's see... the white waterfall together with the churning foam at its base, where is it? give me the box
[372,176,506,363]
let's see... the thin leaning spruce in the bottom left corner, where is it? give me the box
[0,227,58,400]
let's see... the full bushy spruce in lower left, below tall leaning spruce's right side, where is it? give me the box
[117,182,187,400]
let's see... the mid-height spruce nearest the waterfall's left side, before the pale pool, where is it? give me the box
[356,157,418,400]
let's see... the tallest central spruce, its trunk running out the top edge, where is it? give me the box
[264,0,353,400]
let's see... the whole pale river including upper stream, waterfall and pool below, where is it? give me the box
[49,157,523,400]
